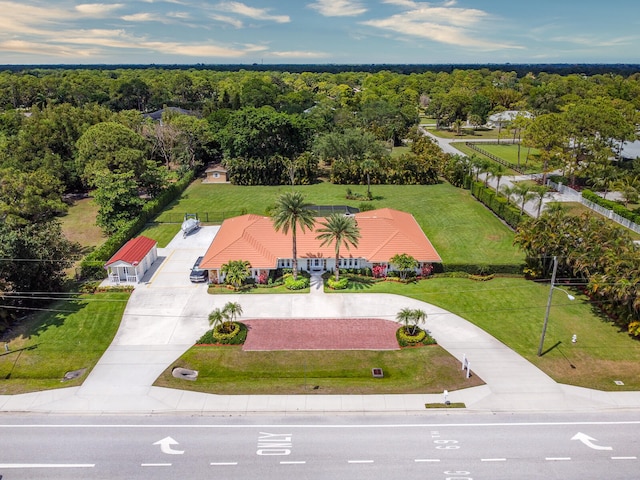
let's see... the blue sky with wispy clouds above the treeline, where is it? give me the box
[0,0,640,64]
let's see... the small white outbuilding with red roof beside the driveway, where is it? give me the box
[104,236,158,284]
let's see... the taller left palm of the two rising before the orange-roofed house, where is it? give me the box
[272,191,315,280]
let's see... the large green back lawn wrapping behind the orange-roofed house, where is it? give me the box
[145,181,524,264]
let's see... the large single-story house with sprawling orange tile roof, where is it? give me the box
[200,208,442,283]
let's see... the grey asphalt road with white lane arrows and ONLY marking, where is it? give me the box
[0,412,640,480]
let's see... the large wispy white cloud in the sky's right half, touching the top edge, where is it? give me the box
[362,0,521,50]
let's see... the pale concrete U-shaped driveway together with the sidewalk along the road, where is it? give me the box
[0,227,640,414]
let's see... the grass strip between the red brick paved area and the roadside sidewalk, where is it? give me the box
[155,344,482,395]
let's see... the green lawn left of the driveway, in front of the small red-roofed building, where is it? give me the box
[0,293,129,394]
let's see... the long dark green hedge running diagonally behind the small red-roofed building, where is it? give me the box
[80,172,195,279]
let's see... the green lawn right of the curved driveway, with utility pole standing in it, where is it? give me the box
[332,277,640,391]
